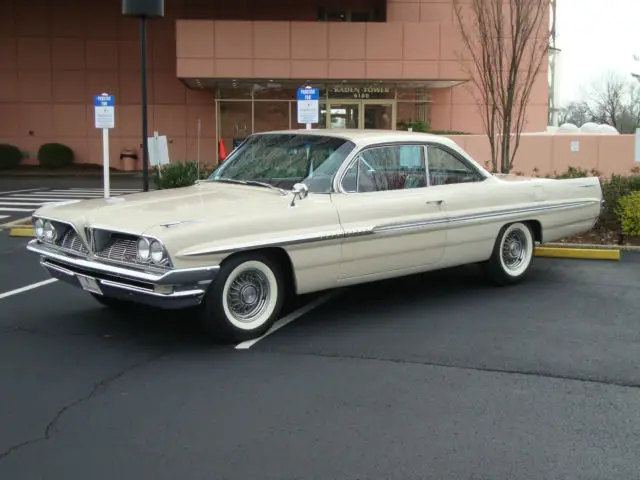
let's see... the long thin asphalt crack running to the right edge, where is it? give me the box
[266,350,640,389]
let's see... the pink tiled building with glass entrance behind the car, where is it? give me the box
[0,0,548,168]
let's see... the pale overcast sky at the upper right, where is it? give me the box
[556,0,640,104]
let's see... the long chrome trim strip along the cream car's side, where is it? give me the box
[185,200,600,257]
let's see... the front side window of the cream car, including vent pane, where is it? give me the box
[342,145,427,193]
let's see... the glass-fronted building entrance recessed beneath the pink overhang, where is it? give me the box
[182,78,464,160]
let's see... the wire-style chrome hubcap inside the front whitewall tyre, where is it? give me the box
[227,269,271,323]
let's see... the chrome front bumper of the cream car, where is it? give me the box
[27,240,220,285]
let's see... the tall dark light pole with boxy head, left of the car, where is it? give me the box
[122,0,164,192]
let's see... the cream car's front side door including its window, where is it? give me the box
[332,143,446,283]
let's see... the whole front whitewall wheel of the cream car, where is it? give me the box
[200,254,285,343]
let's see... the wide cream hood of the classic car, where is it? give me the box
[35,182,291,234]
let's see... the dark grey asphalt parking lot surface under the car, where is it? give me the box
[0,232,640,480]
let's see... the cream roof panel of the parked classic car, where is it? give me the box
[255,128,455,145]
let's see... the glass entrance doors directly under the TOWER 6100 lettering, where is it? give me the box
[326,100,396,130]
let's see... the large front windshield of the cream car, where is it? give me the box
[208,133,355,193]
